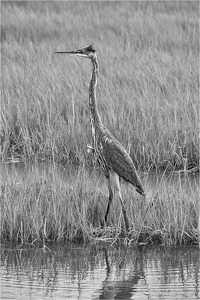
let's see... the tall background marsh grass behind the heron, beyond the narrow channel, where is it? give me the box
[1,1,199,171]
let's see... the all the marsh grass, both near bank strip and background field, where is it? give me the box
[1,1,199,245]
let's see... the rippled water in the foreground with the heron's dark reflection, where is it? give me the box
[0,244,200,300]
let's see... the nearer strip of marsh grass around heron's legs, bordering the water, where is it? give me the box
[1,165,199,245]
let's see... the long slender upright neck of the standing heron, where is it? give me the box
[89,58,101,124]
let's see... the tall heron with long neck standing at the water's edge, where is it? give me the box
[54,45,145,231]
